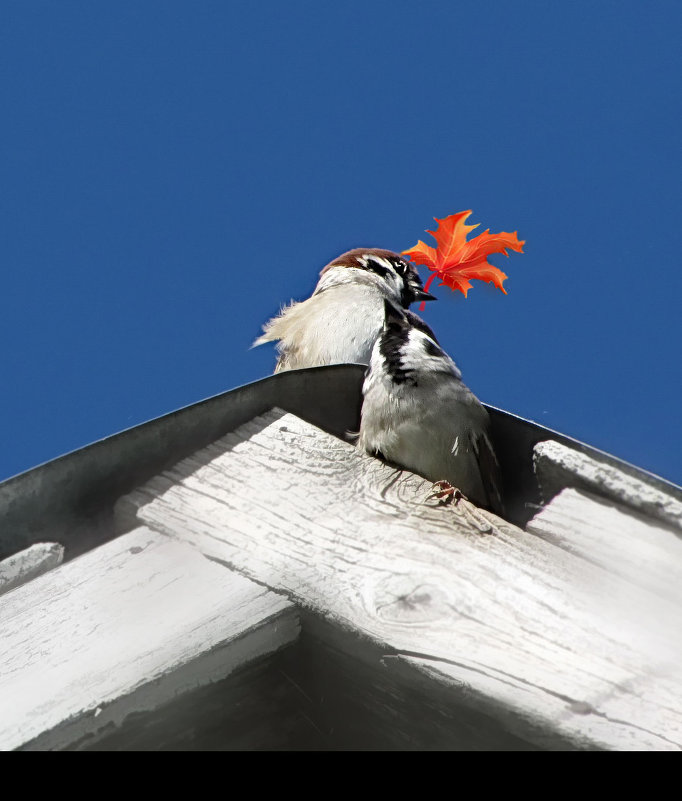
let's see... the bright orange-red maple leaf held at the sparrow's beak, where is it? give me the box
[402,211,525,310]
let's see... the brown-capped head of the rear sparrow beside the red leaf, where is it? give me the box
[315,248,436,309]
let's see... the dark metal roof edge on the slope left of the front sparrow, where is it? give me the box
[0,365,366,559]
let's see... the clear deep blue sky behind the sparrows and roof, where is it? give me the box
[0,0,682,483]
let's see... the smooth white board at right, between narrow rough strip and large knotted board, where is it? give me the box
[527,482,682,608]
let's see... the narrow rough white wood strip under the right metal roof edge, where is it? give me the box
[533,440,682,529]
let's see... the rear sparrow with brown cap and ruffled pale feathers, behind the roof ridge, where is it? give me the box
[253,248,436,373]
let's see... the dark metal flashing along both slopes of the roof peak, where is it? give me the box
[0,365,682,559]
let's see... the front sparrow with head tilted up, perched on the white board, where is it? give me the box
[357,302,504,514]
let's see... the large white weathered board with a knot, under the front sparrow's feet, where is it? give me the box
[118,410,682,750]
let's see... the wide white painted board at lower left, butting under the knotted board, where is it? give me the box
[0,527,298,750]
